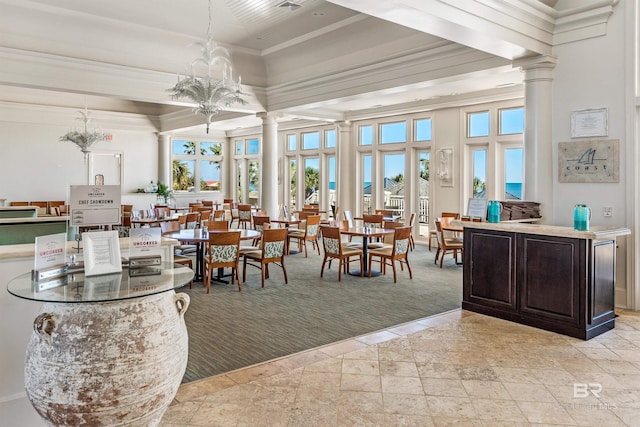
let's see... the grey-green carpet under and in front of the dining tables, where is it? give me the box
[181,245,462,382]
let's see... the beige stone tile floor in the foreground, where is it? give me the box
[161,310,640,427]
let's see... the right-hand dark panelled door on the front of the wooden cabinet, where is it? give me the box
[518,234,587,327]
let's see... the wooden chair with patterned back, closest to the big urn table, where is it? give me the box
[203,231,242,293]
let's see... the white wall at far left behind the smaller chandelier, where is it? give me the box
[0,103,158,205]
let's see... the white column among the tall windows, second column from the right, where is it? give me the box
[336,121,362,219]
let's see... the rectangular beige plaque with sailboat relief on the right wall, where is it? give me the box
[558,139,620,182]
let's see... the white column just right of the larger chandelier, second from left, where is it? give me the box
[258,113,278,218]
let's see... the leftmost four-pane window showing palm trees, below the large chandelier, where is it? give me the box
[171,139,222,192]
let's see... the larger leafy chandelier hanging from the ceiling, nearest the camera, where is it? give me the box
[168,0,247,133]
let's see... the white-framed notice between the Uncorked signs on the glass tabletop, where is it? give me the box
[82,230,122,276]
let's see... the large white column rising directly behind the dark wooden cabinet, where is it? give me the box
[514,56,556,224]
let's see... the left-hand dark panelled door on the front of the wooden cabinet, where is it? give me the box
[463,228,517,312]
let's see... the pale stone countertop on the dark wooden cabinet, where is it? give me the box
[452,221,631,240]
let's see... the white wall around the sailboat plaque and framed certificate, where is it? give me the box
[552,5,633,307]
